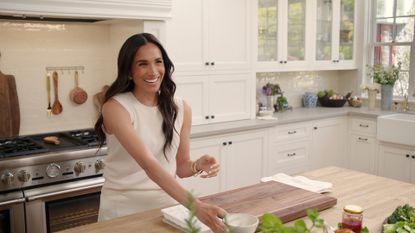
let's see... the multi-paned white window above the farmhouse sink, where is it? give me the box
[369,0,415,97]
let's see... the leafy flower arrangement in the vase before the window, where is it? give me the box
[367,62,401,86]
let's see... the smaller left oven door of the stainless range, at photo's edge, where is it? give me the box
[0,191,25,233]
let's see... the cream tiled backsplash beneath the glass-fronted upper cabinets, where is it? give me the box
[256,70,359,108]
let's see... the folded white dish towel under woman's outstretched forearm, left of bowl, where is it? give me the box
[161,205,212,233]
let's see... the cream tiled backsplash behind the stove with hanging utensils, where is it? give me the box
[0,20,143,135]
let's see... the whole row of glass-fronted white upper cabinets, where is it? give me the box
[256,0,356,71]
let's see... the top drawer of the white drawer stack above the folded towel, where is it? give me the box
[270,124,310,143]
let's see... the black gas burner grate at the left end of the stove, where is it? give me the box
[0,137,49,158]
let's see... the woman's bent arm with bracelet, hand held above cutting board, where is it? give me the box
[176,101,219,178]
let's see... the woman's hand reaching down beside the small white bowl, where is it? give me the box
[194,201,227,233]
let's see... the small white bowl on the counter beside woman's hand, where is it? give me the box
[226,213,259,233]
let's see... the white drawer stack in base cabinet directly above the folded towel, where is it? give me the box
[265,122,311,176]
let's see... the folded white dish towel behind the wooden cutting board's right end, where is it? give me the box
[261,173,333,193]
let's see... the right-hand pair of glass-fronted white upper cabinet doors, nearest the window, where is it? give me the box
[310,0,357,70]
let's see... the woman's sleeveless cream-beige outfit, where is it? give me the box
[98,92,184,221]
